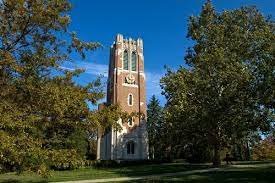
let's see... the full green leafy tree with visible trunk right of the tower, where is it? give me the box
[161,1,275,165]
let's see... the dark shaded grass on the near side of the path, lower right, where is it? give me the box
[131,162,275,183]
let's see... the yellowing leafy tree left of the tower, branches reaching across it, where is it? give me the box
[0,0,119,175]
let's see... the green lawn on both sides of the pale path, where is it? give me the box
[0,162,275,183]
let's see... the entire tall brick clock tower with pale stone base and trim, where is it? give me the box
[97,34,148,160]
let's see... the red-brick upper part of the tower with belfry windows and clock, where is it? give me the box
[107,34,146,120]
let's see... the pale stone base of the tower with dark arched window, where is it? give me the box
[97,120,149,161]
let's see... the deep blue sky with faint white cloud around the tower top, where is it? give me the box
[64,0,275,104]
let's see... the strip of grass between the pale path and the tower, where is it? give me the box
[0,164,209,183]
